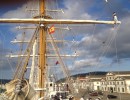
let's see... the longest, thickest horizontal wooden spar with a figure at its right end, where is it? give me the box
[0,18,121,24]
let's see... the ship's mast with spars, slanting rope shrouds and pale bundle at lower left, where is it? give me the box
[0,0,121,100]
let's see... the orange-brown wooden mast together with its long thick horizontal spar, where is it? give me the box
[0,0,121,98]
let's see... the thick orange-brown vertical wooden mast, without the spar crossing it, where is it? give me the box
[39,0,46,98]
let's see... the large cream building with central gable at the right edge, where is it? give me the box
[101,71,130,93]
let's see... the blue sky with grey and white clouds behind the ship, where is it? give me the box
[0,0,130,78]
